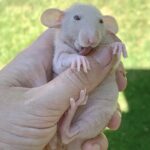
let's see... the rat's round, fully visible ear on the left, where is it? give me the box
[41,8,64,28]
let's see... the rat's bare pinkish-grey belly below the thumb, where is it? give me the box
[72,73,118,139]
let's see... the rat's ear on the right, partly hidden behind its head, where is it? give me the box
[103,16,119,34]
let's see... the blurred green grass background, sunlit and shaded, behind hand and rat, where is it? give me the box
[0,0,150,150]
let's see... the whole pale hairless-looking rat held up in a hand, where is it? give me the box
[41,4,127,150]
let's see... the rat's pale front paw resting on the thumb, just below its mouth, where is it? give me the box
[71,55,90,73]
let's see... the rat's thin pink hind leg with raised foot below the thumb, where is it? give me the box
[60,90,88,144]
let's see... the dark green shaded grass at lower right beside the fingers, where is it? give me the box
[106,69,150,150]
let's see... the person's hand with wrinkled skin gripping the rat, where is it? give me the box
[0,29,126,150]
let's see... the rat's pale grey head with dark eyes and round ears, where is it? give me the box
[41,4,118,52]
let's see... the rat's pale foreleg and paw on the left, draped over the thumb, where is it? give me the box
[53,31,90,74]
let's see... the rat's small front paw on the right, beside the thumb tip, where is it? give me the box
[110,42,127,59]
